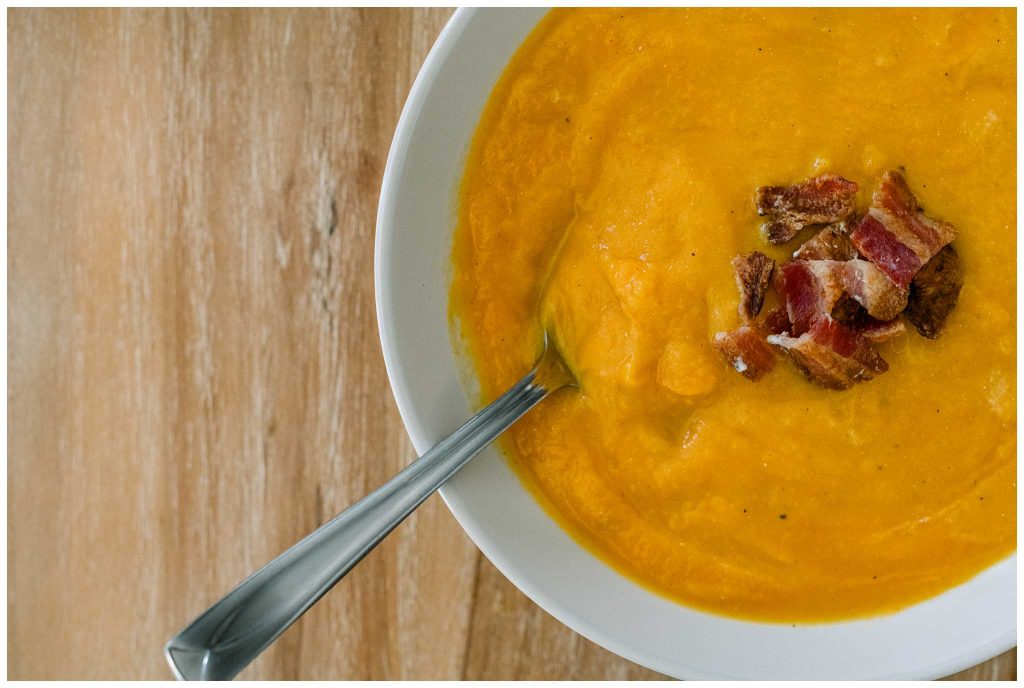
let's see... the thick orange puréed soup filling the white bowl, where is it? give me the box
[451,9,1017,621]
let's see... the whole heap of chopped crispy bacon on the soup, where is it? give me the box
[714,166,964,389]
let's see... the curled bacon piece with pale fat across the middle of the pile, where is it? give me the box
[775,259,906,336]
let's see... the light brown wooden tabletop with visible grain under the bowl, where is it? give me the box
[7,9,1016,679]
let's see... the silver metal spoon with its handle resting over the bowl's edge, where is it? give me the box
[164,337,577,680]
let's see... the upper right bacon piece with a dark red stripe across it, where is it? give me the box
[850,170,956,289]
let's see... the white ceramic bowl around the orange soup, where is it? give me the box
[374,9,1017,679]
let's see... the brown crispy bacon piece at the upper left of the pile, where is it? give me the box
[755,174,859,244]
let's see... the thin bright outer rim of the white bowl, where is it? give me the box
[374,7,1017,680]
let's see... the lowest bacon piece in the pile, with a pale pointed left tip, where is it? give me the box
[768,315,889,389]
